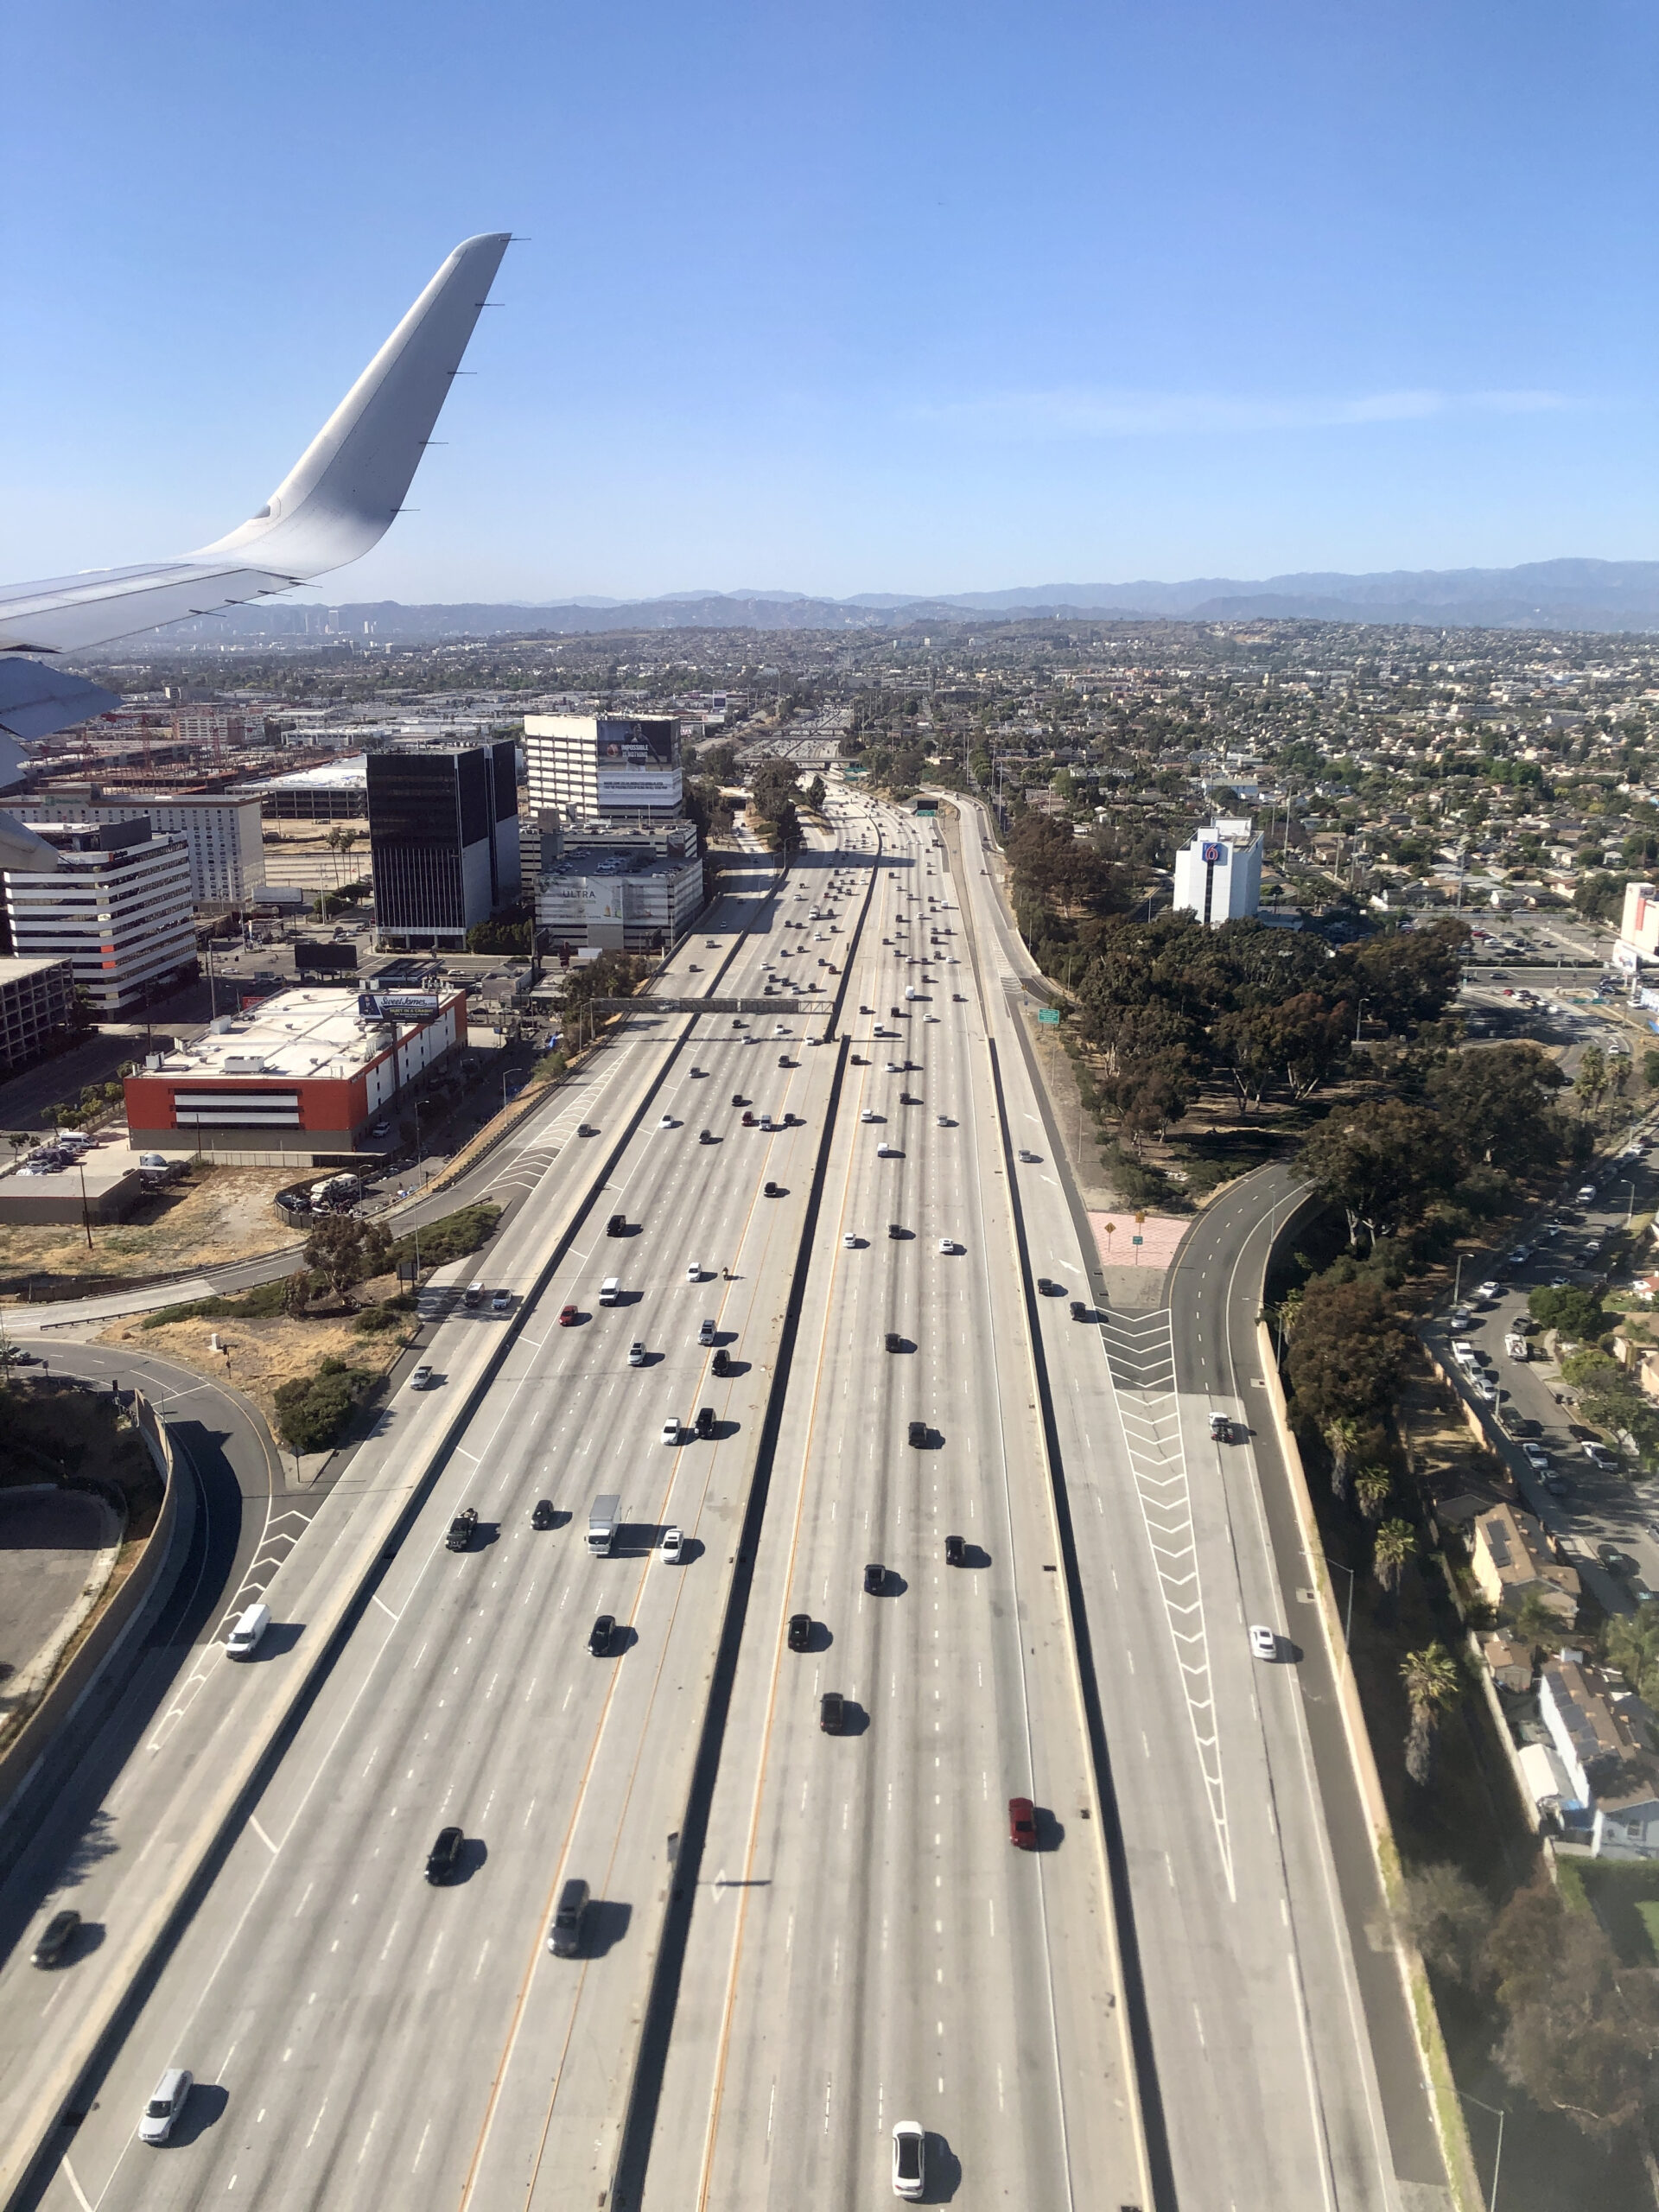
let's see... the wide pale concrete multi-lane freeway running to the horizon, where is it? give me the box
[0,803,1438,2212]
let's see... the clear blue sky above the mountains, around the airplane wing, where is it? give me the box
[0,0,1659,600]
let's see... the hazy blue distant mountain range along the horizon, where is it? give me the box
[115,560,1659,657]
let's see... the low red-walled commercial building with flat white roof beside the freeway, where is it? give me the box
[126,987,467,1168]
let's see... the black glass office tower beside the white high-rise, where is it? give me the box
[367,739,520,947]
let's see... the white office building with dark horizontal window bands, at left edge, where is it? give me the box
[0,821,194,1022]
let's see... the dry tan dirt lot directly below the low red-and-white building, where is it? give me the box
[0,1166,294,1279]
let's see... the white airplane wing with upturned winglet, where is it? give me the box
[0,232,509,664]
